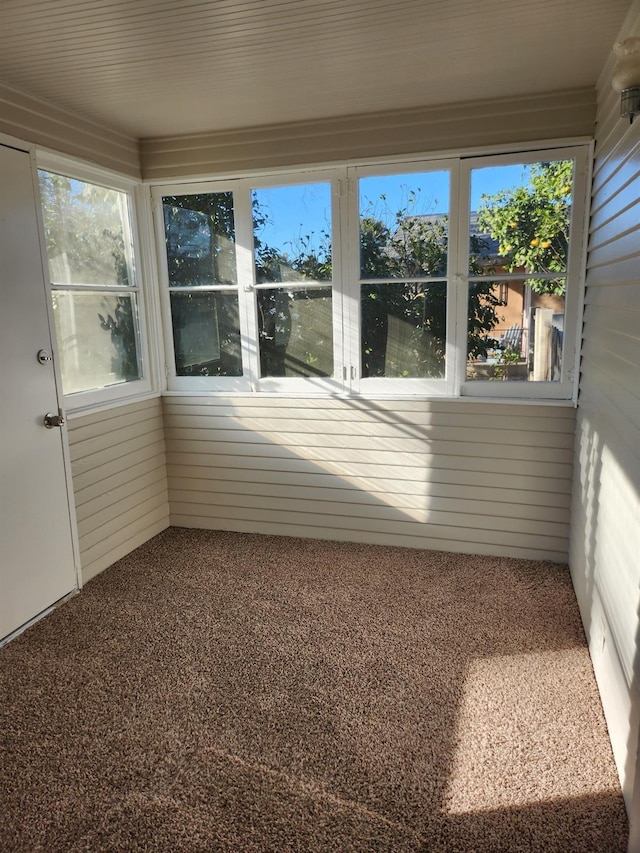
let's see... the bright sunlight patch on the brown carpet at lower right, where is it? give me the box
[445,648,618,814]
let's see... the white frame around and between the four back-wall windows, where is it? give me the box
[151,140,592,403]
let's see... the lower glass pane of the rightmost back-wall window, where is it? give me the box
[467,279,566,382]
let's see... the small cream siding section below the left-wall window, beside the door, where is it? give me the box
[69,398,169,582]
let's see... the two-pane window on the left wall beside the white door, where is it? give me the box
[38,169,149,407]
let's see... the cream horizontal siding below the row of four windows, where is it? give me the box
[164,396,575,561]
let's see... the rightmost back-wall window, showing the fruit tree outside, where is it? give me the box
[465,157,579,393]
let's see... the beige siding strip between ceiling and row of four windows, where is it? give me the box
[141,89,595,180]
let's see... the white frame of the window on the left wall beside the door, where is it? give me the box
[36,151,159,414]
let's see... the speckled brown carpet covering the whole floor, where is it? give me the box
[0,528,628,853]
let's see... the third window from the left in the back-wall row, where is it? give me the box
[354,169,451,393]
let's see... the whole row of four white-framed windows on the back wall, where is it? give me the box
[153,147,587,399]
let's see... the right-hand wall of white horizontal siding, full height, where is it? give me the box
[570,4,640,840]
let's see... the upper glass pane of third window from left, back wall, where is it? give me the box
[359,172,449,279]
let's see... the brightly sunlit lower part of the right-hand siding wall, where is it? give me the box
[571,399,640,853]
